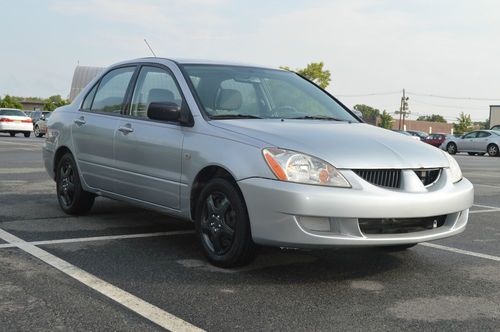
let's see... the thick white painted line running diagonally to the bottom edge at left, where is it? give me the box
[0,229,203,331]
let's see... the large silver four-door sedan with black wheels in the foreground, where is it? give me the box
[43,58,474,267]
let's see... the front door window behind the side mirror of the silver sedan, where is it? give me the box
[130,67,182,118]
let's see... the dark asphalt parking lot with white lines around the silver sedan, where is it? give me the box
[0,134,500,331]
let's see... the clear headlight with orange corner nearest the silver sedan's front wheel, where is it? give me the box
[262,148,351,188]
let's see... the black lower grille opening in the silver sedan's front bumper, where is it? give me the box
[358,215,446,234]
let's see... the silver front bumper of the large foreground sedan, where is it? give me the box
[238,169,474,248]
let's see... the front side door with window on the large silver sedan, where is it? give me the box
[115,65,186,210]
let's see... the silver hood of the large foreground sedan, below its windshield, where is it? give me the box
[210,119,449,169]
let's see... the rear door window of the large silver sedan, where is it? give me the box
[90,67,135,113]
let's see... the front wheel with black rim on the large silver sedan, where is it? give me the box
[195,178,258,268]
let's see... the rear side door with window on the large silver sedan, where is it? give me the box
[72,66,136,191]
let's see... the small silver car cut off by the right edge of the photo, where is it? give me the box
[441,130,500,157]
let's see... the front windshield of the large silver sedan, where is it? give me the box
[183,65,359,122]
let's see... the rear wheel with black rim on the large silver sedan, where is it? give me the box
[56,153,95,215]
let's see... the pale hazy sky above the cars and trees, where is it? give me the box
[0,0,500,120]
